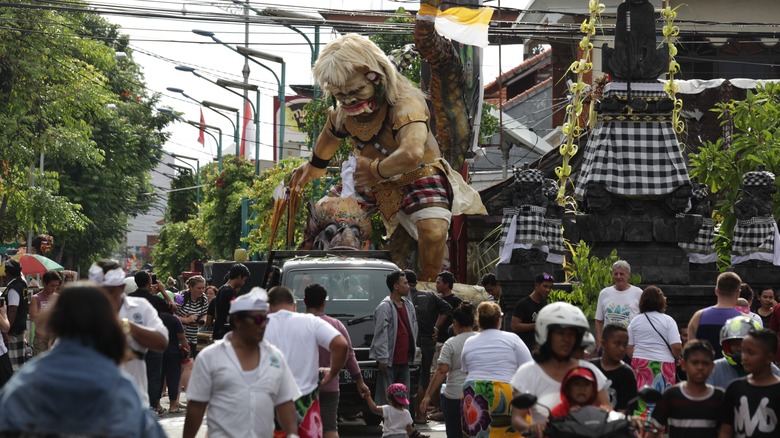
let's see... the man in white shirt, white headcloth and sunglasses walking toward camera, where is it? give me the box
[183,287,302,438]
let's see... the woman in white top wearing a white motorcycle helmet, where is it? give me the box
[512,302,611,437]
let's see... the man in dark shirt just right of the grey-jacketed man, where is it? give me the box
[404,269,454,423]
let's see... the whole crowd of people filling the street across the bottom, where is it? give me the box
[0,260,780,438]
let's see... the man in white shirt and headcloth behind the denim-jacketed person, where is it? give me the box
[89,260,168,405]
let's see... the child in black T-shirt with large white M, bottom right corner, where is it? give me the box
[718,329,780,438]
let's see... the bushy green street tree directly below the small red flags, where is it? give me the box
[195,156,254,260]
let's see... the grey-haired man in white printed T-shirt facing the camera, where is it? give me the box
[593,260,642,345]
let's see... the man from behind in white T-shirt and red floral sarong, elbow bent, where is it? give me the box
[265,286,349,438]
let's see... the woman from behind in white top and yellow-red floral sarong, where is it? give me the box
[461,301,531,437]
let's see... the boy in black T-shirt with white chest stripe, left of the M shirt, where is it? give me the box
[652,339,723,438]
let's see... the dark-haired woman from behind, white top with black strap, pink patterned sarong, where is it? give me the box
[628,286,682,392]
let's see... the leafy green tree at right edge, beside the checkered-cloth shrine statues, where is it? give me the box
[689,82,780,267]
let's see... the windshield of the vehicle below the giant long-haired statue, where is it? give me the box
[283,268,392,348]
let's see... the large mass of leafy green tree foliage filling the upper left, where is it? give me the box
[0,0,168,267]
